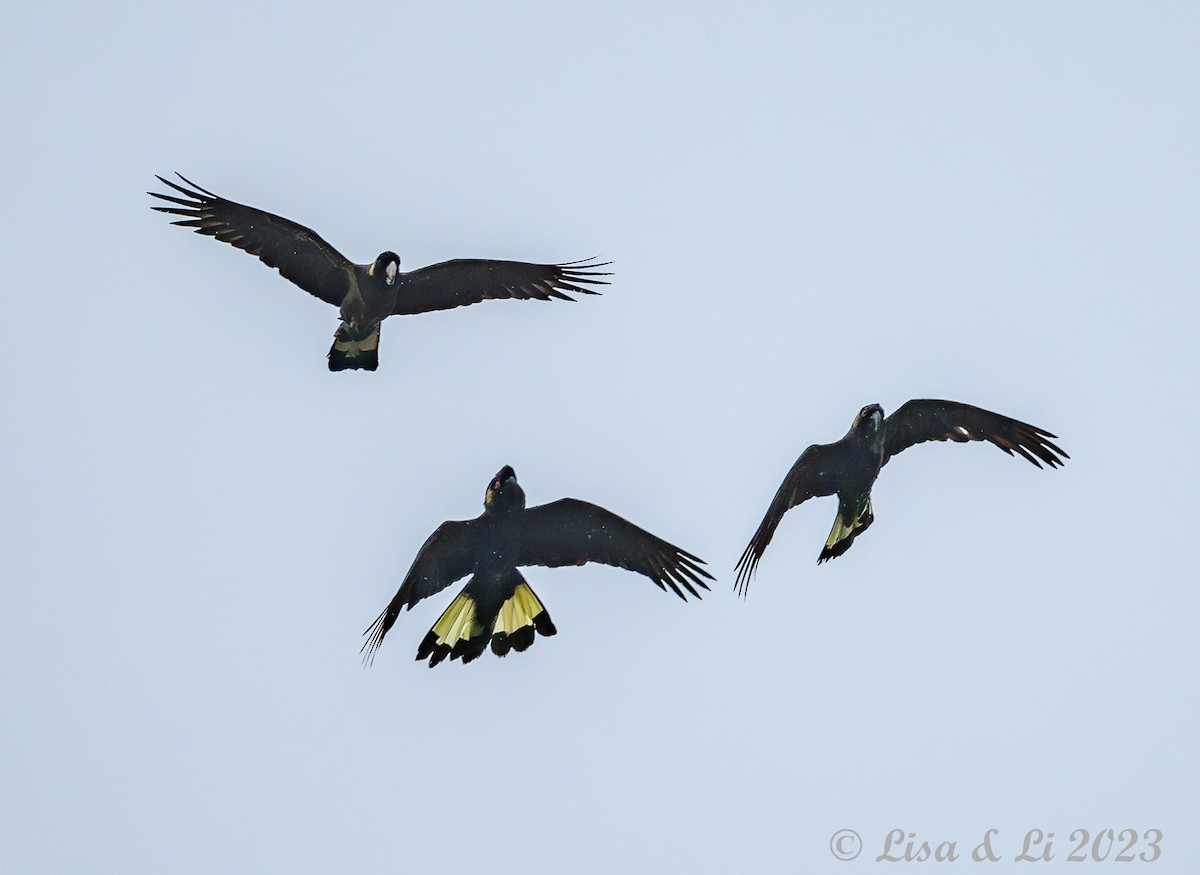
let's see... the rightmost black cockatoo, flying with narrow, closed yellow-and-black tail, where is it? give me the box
[734,400,1070,595]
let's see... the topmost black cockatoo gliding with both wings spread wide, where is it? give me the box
[146,174,611,371]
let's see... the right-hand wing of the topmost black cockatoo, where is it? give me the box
[391,258,611,316]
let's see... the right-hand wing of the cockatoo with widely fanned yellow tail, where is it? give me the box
[517,498,713,600]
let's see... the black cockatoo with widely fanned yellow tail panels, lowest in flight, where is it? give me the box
[362,466,713,667]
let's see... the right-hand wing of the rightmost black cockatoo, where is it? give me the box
[883,398,1070,468]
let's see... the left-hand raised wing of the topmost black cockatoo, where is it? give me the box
[146,174,354,307]
